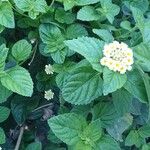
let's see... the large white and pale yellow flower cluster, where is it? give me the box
[100,41,134,74]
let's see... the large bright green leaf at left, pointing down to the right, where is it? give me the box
[1,66,33,96]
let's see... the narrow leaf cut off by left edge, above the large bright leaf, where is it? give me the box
[0,44,8,72]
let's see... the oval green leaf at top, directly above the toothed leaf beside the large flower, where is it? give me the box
[77,6,101,21]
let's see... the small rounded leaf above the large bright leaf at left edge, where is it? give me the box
[12,40,32,62]
